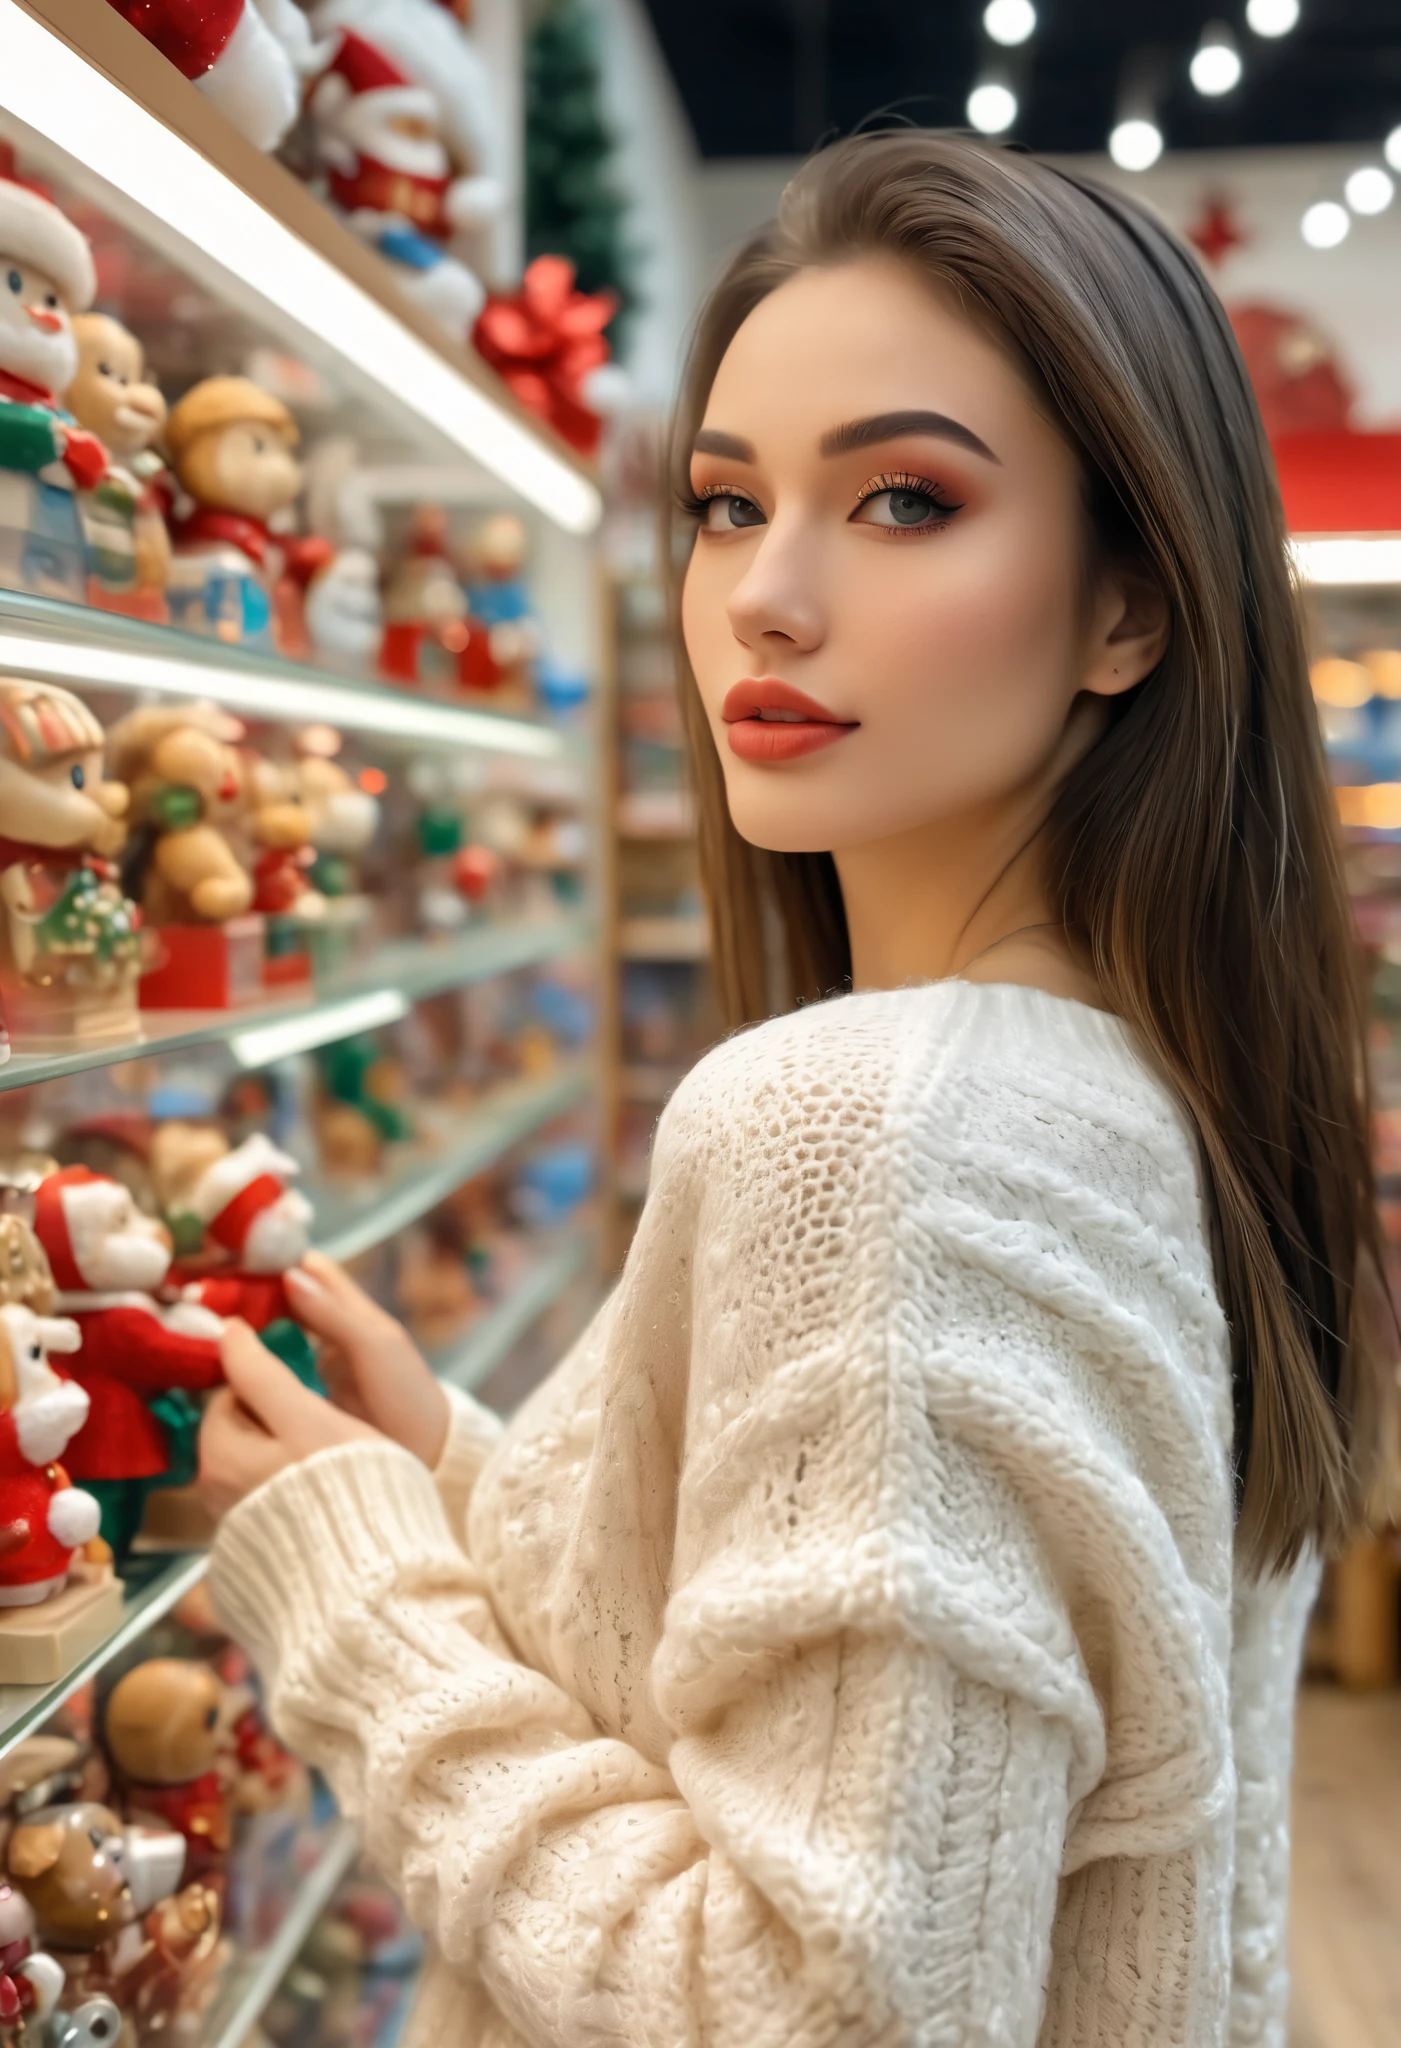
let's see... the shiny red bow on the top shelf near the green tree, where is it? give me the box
[473,256,619,455]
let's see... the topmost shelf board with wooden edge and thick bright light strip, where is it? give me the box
[0,0,602,532]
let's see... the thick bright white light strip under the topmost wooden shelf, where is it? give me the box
[0,0,602,532]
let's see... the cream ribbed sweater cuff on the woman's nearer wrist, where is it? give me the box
[209,1444,463,1673]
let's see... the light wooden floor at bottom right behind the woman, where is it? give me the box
[1288,1686,1401,2048]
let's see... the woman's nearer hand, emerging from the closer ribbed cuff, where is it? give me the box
[199,1323,383,1518]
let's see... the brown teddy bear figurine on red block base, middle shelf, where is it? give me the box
[111,700,262,1010]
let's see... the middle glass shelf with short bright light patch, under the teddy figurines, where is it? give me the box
[0,918,594,1092]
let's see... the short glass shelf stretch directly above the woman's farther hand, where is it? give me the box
[313,1061,594,1260]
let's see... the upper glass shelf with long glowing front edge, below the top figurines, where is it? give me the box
[0,593,580,762]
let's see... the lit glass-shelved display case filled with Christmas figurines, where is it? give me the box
[0,0,606,2048]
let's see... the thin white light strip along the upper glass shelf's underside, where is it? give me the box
[0,629,565,760]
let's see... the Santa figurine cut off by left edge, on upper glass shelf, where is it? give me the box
[0,178,109,604]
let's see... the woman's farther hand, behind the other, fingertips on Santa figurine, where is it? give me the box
[283,1251,449,1470]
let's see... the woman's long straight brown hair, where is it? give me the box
[672,129,1395,1569]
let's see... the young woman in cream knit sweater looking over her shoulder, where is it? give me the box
[203,133,1387,2048]
